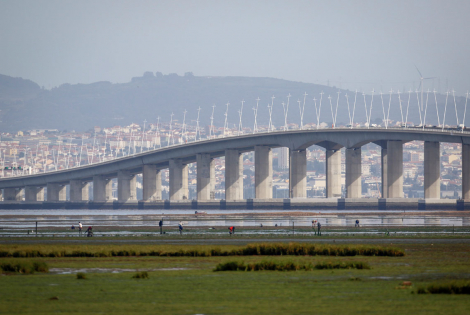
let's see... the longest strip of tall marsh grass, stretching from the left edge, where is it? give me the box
[0,243,405,258]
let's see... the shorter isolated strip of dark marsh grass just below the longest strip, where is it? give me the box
[214,261,370,271]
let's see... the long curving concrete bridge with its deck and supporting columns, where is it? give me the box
[0,128,470,208]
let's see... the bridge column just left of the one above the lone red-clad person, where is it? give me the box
[196,153,215,200]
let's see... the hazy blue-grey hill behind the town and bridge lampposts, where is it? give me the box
[0,72,465,132]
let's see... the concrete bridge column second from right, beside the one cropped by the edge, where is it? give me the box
[424,141,441,199]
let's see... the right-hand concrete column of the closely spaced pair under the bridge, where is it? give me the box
[346,148,362,198]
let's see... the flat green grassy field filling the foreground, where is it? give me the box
[0,240,470,314]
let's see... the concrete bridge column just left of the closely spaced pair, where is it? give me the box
[289,149,307,198]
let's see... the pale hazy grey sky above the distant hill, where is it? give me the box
[0,0,470,95]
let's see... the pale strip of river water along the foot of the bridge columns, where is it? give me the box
[0,210,470,233]
